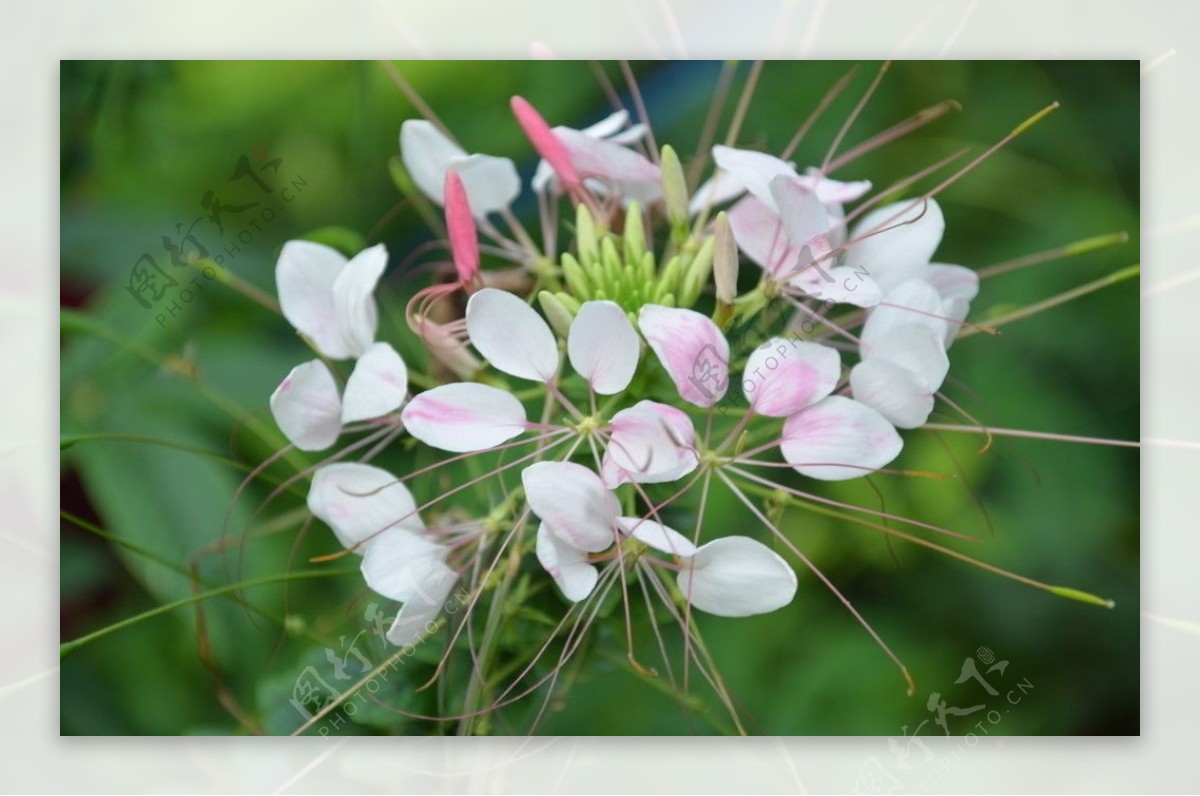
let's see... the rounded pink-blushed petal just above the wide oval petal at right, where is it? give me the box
[742,337,841,418]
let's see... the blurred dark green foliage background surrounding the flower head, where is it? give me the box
[60,61,1139,735]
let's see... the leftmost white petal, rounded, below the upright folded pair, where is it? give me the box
[271,359,342,450]
